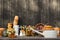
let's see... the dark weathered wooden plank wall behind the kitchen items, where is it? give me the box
[0,0,60,27]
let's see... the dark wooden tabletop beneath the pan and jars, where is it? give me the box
[0,36,60,40]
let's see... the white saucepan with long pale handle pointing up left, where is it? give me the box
[30,27,57,38]
